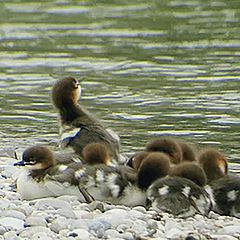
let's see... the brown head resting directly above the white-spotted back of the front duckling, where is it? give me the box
[169,162,207,186]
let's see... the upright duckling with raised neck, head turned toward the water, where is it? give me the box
[52,77,120,160]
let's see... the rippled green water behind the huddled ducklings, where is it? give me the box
[0,0,240,169]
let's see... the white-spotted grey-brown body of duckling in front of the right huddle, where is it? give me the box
[147,176,212,218]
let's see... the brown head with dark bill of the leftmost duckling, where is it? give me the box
[15,145,55,169]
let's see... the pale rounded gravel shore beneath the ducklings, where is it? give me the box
[0,151,240,240]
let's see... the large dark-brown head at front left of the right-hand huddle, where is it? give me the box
[138,152,170,189]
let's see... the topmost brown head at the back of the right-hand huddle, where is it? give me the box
[146,138,182,164]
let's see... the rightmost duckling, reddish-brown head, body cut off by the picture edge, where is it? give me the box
[199,149,240,218]
